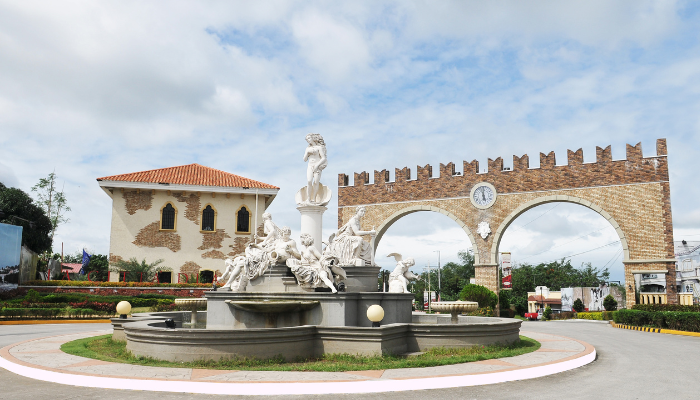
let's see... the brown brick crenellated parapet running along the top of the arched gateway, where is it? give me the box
[338,139,668,207]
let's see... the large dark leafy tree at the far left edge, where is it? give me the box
[0,183,51,253]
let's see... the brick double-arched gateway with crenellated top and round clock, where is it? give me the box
[338,139,677,307]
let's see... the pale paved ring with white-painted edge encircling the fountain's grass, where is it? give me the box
[0,332,596,395]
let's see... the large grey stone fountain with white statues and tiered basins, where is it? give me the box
[112,134,521,361]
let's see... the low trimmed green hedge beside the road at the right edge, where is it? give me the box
[613,310,700,332]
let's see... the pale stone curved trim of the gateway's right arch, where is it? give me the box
[491,195,630,263]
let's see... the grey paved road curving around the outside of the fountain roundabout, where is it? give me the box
[0,321,700,400]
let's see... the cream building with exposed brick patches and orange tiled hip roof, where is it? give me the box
[97,164,279,283]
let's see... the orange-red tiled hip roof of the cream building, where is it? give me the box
[97,164,279,189]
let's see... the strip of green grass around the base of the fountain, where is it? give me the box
[61,335,540,372]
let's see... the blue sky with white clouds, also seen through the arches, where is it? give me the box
[0,0,700,280]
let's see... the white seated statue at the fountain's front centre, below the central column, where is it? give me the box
[287,233,345,293]
